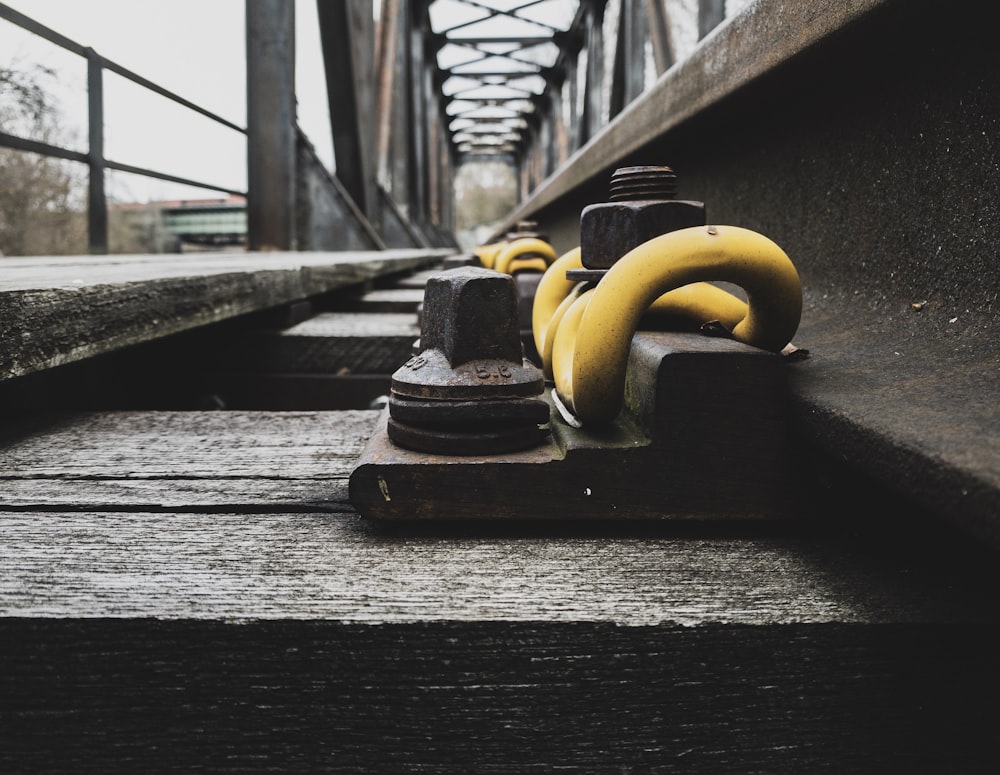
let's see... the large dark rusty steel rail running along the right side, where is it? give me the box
[484,0,1000,548]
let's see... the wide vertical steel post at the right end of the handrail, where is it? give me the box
[246,0,296,250]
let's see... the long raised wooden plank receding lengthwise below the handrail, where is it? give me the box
[0,250,449,379]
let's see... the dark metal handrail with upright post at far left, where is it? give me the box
[0,3,247,253]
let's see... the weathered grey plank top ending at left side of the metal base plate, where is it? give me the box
[0,411,378,511]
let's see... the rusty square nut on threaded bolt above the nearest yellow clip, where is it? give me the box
[580,166,706,269]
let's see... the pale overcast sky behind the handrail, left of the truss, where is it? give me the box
[0,0,333,201]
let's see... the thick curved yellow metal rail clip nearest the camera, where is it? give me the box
[535,226,802,425]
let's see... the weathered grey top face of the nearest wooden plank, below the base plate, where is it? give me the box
[0,510,997,627]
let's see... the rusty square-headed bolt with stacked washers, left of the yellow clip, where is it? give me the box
[388,267,549,455]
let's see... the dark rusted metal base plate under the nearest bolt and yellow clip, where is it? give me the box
[350,334,794,520]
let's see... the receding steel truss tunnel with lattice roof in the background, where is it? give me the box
[304,0,737,246]
